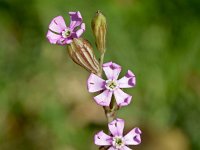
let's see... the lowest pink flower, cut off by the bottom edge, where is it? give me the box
[94,118,142,150]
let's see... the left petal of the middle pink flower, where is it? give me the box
[87,73,105,92]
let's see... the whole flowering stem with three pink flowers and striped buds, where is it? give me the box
[46,11,142,150]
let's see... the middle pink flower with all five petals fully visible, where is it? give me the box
[87,62,136,106]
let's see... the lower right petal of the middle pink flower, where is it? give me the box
[114,89,132,106]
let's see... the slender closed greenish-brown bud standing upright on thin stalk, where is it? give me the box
[91,11,107,53]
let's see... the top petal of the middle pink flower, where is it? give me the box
[103,62,121,80]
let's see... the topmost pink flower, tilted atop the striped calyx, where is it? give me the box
[46,11,85,45]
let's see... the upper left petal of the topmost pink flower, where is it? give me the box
[49,16,66,33]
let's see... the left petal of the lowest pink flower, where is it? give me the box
[94,131,112,146]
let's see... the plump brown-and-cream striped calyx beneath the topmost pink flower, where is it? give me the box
[67,38,99,74]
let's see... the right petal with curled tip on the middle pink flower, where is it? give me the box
[118,70,136,88]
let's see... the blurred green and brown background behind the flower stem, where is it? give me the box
[0,0,200,150]
